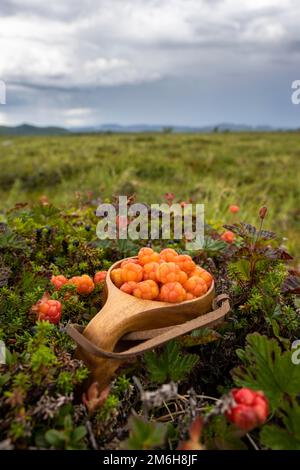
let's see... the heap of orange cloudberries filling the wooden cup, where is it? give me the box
[111,248,213,303]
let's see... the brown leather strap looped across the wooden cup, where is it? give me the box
[66,294,230,360]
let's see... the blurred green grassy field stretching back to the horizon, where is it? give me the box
[0,132,300,255]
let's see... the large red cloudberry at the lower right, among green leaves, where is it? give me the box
[226,387,269,432]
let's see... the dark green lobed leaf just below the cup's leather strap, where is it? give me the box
[145,341,199,383]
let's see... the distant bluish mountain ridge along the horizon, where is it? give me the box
[0,123,295,136]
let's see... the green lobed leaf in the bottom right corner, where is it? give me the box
[260,399,300,450]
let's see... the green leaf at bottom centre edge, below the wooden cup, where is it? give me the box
[122,416,168,450]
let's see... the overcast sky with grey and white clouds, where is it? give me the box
[0,0,300,127]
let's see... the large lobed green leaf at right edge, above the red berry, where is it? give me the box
[233,333,300,408]
